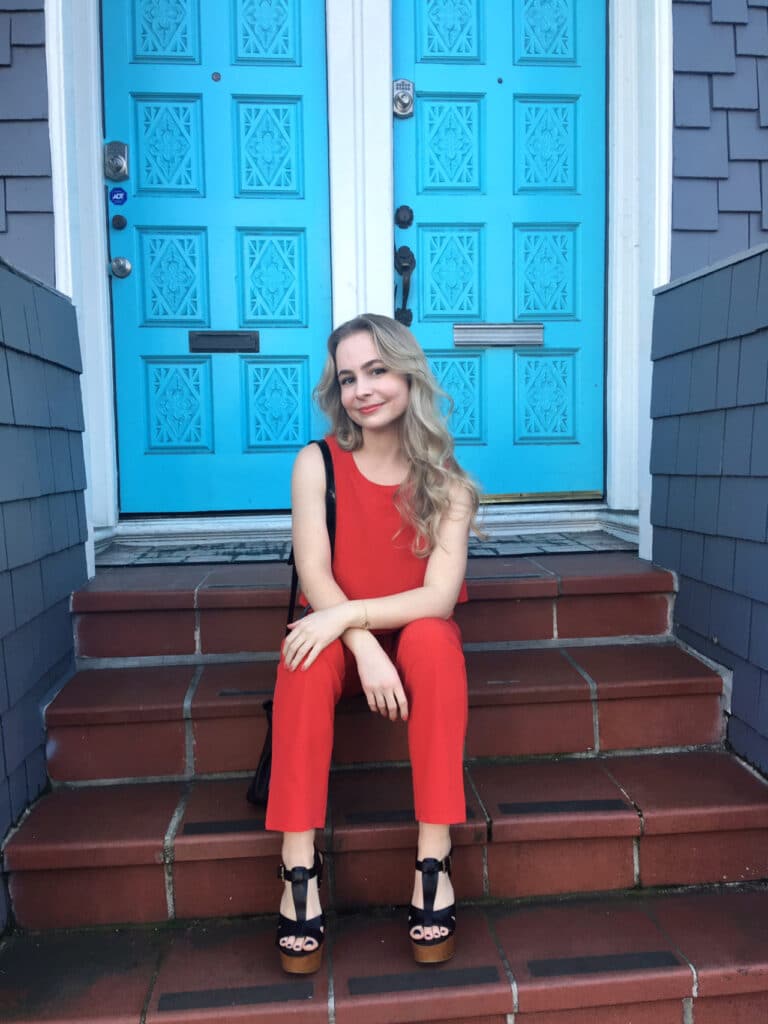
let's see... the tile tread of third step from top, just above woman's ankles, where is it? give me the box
[5,752,768,871]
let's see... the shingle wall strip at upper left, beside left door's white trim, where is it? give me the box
[0,0,54,285]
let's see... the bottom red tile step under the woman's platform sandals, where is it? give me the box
[0,887,768,1024]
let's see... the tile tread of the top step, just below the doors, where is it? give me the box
[72,551,674,613]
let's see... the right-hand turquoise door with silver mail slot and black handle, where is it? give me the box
[393,0,606,500]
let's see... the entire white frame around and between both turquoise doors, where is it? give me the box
[45,0,672,572]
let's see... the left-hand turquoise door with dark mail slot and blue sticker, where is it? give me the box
[102,0,331,513]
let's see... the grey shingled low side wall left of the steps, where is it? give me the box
[0,260,87,932]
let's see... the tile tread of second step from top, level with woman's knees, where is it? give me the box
[46,643,722,727]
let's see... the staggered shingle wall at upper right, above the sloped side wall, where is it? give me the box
[672,0,768,279]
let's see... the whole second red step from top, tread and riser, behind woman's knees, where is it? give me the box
[46,644,724,782]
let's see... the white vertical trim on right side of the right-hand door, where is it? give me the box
[605,0,672,558]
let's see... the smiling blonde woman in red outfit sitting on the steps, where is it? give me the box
[266,314,478,974]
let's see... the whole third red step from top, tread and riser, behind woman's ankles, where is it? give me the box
[5,753,768,929]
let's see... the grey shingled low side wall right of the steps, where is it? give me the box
[650,250,768,771]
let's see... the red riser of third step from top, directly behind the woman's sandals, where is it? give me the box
[10,829,768,930]
